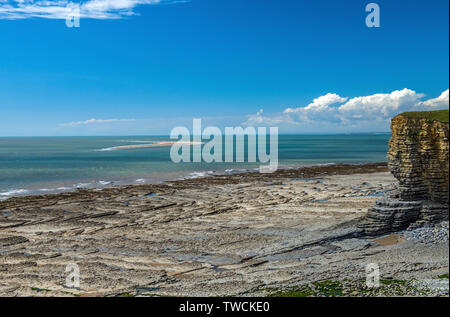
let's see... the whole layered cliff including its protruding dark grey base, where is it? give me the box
[362,111,449,235]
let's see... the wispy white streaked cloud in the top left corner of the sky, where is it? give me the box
[0,0,188,20]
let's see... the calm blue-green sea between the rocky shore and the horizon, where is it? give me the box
[0,134,390,200]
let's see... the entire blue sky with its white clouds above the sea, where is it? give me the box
[0,0,449,136]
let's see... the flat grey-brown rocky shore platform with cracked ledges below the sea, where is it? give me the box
[0,163,449,296]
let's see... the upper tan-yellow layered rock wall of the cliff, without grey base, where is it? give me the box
[388,115,449,204]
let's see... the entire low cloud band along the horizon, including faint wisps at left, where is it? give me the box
[60,88,449,133]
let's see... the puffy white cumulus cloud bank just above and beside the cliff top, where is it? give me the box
[244,88,449,129]
